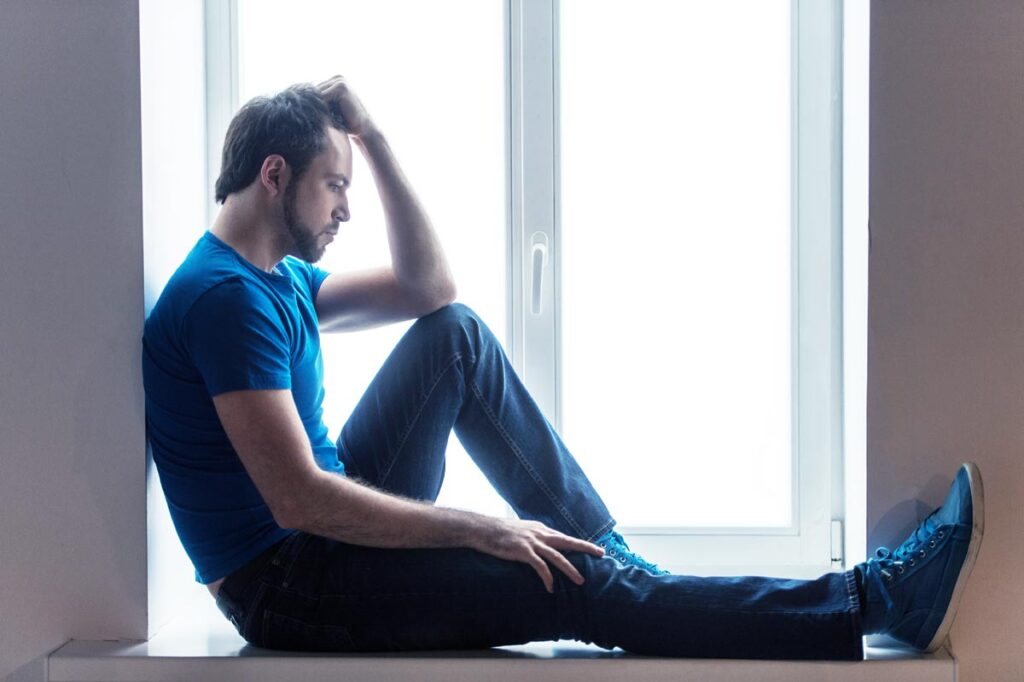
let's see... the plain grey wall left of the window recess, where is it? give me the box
[0,0,146,678]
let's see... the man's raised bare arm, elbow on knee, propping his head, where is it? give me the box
[316,76,456,332]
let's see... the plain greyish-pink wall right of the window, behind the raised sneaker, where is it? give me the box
[867,0,1024,682]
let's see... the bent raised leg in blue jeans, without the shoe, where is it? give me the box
[338,304,614,540]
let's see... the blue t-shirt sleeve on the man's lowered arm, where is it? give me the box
[182,280,292,397]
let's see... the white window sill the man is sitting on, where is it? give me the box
[49,599,956,682]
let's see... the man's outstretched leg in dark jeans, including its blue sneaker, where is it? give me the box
[225,458,984,659]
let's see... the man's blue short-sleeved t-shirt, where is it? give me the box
[142,231,344,583]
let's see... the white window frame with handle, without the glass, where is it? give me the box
[206,0,844,577]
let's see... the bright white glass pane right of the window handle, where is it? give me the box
[559,0,794,526]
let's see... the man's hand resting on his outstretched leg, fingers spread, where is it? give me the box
[469,517,604,592]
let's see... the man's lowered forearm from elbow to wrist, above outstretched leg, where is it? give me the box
[292,464,495,548]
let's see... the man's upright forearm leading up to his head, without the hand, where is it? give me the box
[352,128,455,300]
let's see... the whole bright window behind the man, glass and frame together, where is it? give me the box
[208,0,844,576]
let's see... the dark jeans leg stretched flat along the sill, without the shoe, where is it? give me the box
[243,534,862,659]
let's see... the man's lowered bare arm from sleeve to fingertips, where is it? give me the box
[213,390,603,592]
